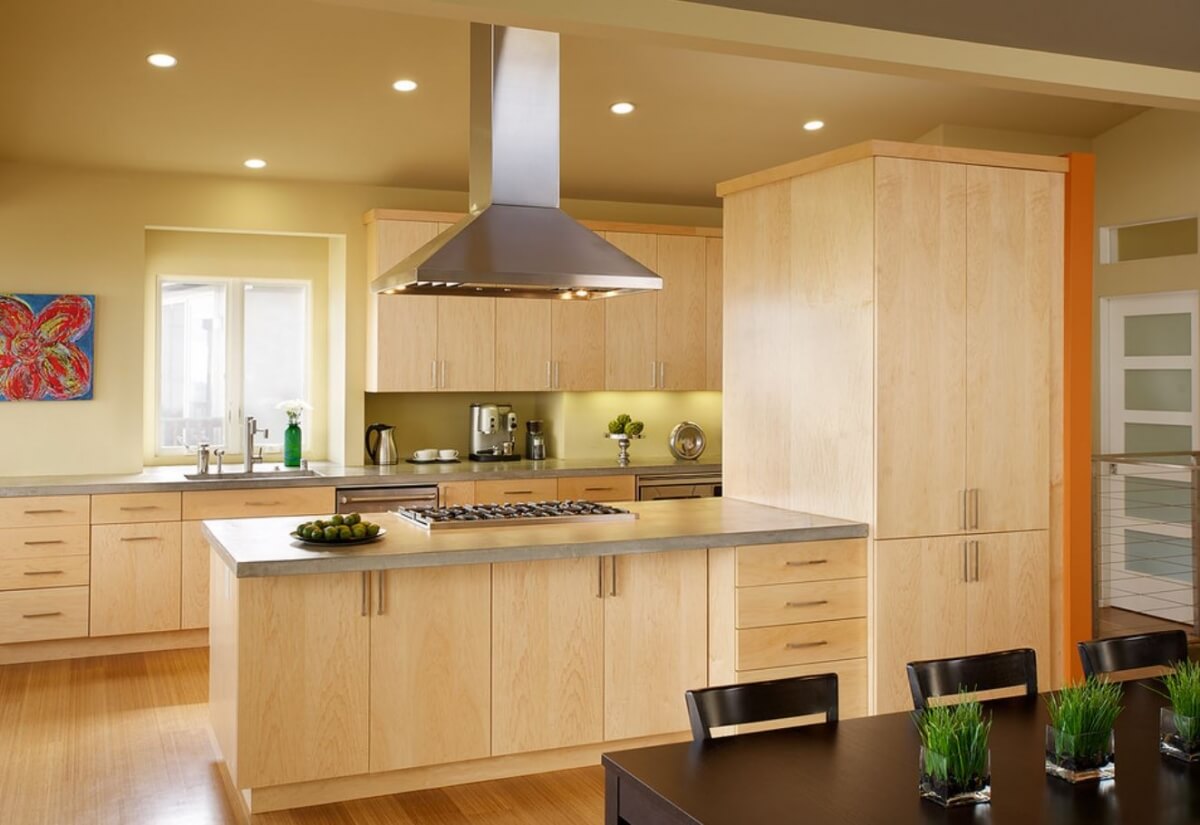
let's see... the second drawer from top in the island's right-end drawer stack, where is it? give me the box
[737,579,866,627]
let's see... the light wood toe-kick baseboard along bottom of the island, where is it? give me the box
[240,733,691,814]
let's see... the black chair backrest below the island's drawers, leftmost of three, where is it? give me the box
[685,673,838,742]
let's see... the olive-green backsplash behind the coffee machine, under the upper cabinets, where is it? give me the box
[362,392,721,462]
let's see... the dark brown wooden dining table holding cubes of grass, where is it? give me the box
[602,681,1200,825]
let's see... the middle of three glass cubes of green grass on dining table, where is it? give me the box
[1045,676,1122,783]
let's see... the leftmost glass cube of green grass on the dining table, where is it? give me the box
[913,699,991,807]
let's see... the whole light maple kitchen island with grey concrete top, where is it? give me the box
[204,499,866,815]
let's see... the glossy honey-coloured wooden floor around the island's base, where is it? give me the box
[0,649,604,825]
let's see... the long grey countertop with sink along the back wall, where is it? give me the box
[0,456,721,498]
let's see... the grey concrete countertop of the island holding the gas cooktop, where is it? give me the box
[204,498,866,578]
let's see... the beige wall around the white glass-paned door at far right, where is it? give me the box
[1092,109,1200,451]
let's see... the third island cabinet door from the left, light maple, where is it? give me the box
[492,558,604,755]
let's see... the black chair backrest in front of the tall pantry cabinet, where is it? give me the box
[908,648,1038,710]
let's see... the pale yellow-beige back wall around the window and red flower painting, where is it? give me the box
[0,163,720,476]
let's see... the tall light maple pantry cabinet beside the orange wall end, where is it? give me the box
[719,141,1067,712]
